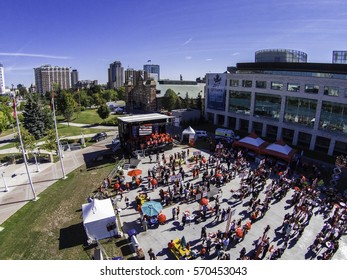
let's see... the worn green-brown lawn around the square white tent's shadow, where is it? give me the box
[0,162,125,260]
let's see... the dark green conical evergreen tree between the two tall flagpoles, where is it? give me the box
[23,94,51,139]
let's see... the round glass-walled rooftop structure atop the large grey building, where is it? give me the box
[255,49,307,63]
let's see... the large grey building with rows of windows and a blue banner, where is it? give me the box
[205,55,347,155]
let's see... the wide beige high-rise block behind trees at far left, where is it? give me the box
[34,64,71,94]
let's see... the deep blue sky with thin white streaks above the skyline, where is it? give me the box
[0,0,347,86]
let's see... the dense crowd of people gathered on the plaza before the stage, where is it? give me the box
[90,141,347,260]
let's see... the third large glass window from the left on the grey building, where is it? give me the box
[284,97,317,127]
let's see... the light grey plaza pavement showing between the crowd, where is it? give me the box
[118,146,347,260]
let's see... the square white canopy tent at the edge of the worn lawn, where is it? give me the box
[82,198,116,240]
